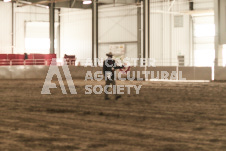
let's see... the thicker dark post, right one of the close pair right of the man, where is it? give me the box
[143,0,150,64]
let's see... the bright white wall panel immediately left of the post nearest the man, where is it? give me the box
[60,9,92,63]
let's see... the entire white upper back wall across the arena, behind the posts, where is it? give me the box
[0,0,213,66]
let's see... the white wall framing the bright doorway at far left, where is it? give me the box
[0,1,58,54]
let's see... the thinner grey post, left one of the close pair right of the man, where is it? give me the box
[137,1,142,65]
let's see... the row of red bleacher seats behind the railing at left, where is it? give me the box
[0,54,56,66]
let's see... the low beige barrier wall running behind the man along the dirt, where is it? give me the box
[0,66,212,81]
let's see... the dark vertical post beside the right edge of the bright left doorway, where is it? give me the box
[49,3,55,54]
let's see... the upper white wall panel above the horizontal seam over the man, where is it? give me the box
[99,6,137,42]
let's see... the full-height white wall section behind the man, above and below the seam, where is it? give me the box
[98,5,137,58]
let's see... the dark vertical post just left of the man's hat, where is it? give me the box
[92,0,98,65]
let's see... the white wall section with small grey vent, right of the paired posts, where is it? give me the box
[150,1,191,66]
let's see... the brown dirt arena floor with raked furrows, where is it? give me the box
[0,80,226,151]
